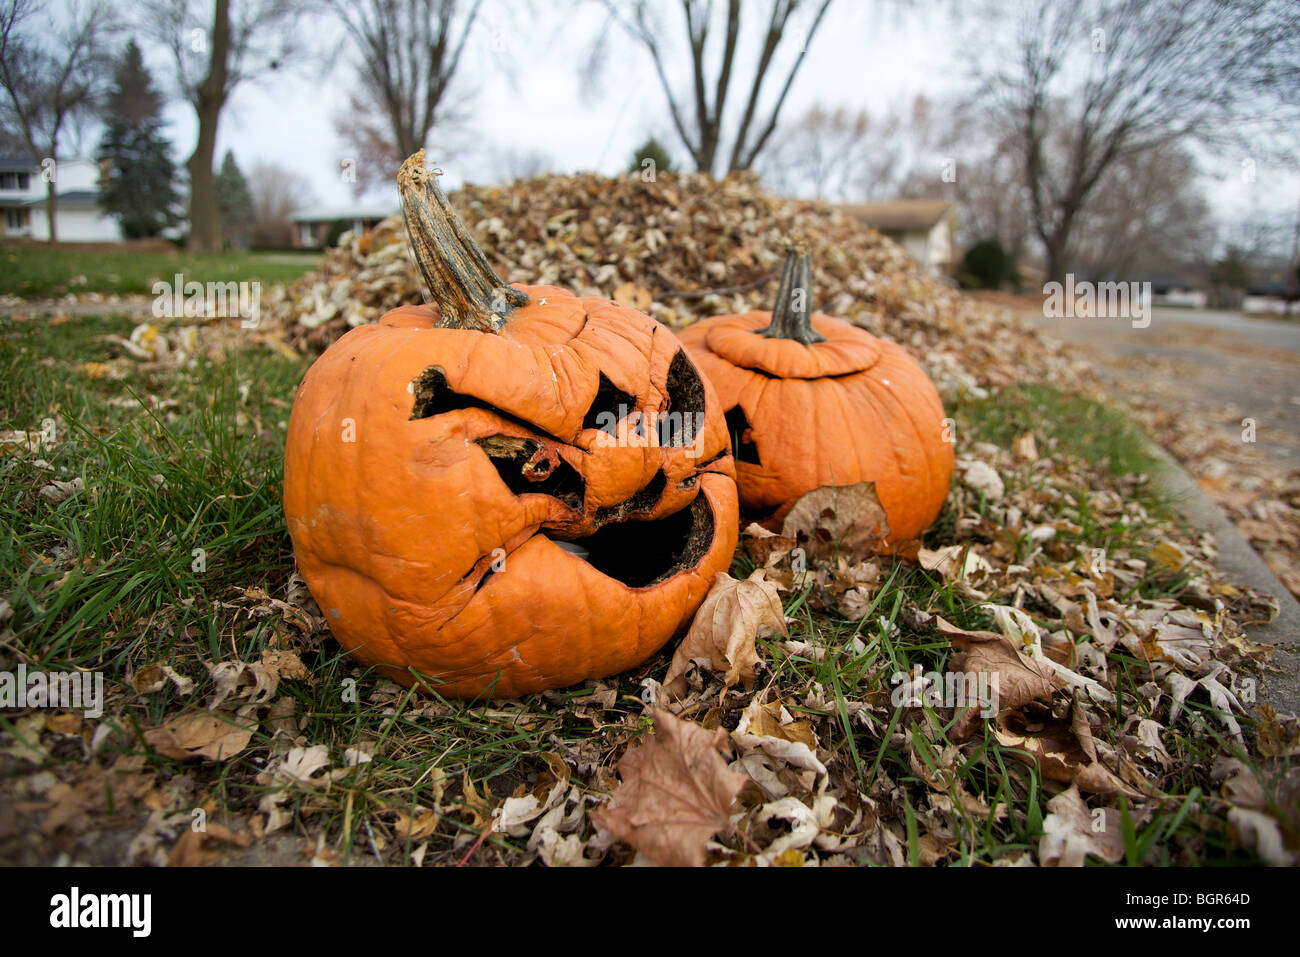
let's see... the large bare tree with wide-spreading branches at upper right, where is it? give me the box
[978,0,1300,278]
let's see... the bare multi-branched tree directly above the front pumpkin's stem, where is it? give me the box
[332,0,482,192]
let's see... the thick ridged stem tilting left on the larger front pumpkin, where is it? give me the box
[398,150,529,333]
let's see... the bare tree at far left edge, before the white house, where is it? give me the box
[0,0,112,242]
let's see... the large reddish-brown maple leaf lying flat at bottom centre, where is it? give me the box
[592,709,745,867]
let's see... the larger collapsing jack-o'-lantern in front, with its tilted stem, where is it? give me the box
[285,151,738,698]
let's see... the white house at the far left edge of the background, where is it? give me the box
[0,157,122,243]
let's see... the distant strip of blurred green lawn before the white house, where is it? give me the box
[0,243,320,299]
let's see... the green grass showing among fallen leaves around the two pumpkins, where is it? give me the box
[0,317,1279,865]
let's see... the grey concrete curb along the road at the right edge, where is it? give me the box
[1151,445,1300,714]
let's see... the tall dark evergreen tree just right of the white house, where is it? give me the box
[98,40,181,239]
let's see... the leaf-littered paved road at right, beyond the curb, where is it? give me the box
[1024,308,1300,468]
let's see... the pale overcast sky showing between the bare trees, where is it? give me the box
[109,0,1300,236]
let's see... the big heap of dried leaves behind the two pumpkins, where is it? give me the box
[265,167,1079,394]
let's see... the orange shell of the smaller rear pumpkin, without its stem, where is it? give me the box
[680,311,953,545]
